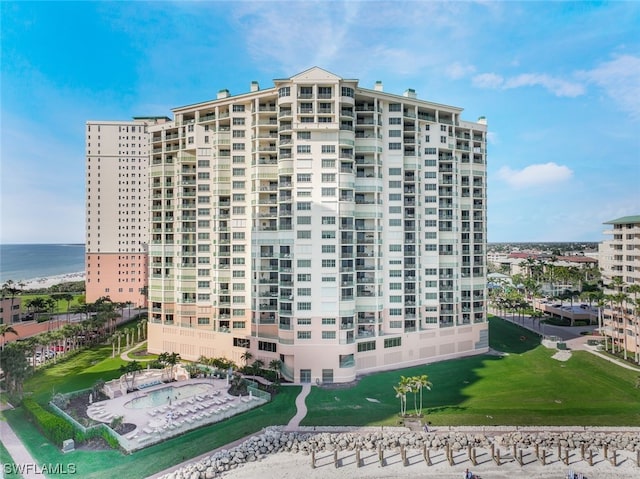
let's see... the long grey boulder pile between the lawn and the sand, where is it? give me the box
[156,428,640,479]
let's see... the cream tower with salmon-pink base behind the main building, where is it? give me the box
[85,117,169,306]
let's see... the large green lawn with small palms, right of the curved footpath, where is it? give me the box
[302,318,640,426]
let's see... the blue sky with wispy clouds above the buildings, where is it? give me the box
[0,1,640,243]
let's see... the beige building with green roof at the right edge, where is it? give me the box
[599,215,640,361]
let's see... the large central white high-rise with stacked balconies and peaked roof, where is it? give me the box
[148,68,488,382]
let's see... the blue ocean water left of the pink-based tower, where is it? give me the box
[0,244,85,283]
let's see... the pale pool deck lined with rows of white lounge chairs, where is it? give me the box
[87,378,266,450]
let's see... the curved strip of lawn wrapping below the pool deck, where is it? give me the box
[3,386,300,479]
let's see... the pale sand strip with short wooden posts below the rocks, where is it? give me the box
[222,449,640,479]
